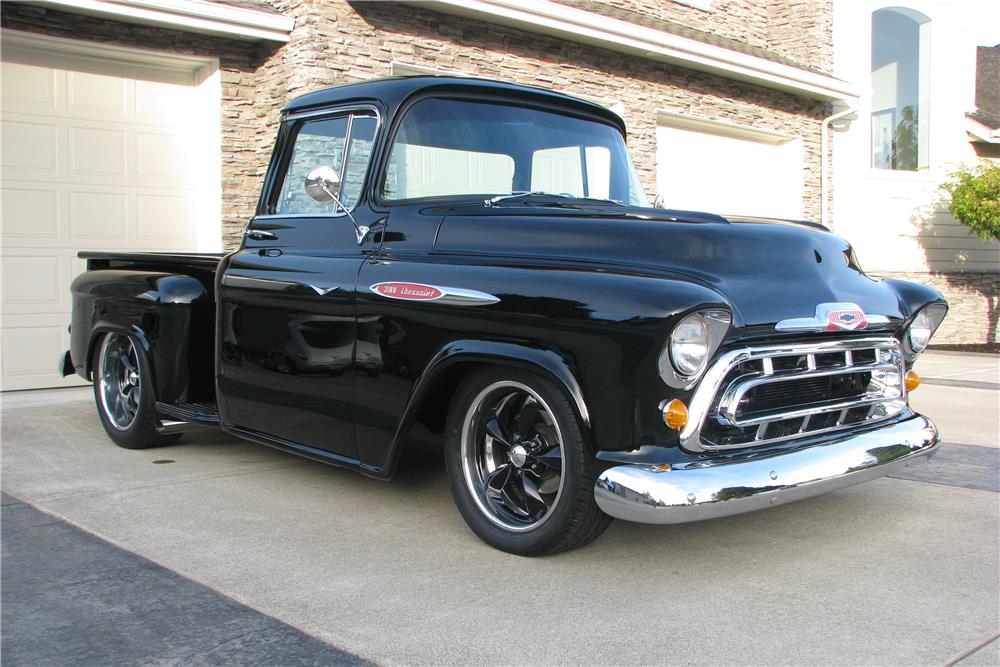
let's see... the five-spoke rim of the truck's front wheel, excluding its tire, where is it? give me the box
[461,381,565,532]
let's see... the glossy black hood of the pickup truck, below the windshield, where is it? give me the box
[434,206,909,328]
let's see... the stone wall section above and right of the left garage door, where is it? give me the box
[0,2,284,246]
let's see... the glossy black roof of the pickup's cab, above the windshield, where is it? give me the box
[284,75,625,135]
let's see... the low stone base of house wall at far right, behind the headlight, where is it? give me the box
[877,272,1000,345]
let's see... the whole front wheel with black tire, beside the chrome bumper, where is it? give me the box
[445,367,611,556]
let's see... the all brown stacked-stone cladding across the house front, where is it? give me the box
[2,0,997,342]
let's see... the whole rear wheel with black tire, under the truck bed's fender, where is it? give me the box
[91,333,180,449]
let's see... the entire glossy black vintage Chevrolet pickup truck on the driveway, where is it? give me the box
[62,77,947,555]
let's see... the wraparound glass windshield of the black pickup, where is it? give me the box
[382,98,649,206]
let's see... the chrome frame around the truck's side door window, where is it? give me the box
[254,104,382,220]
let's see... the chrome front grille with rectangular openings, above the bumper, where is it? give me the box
[681,338,906,450]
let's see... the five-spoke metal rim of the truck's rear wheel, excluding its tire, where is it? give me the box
[97,334,142,431]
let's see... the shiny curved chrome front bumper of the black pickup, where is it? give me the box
[594,415,938,523]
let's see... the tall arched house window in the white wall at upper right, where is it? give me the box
[871,7,930,171]
